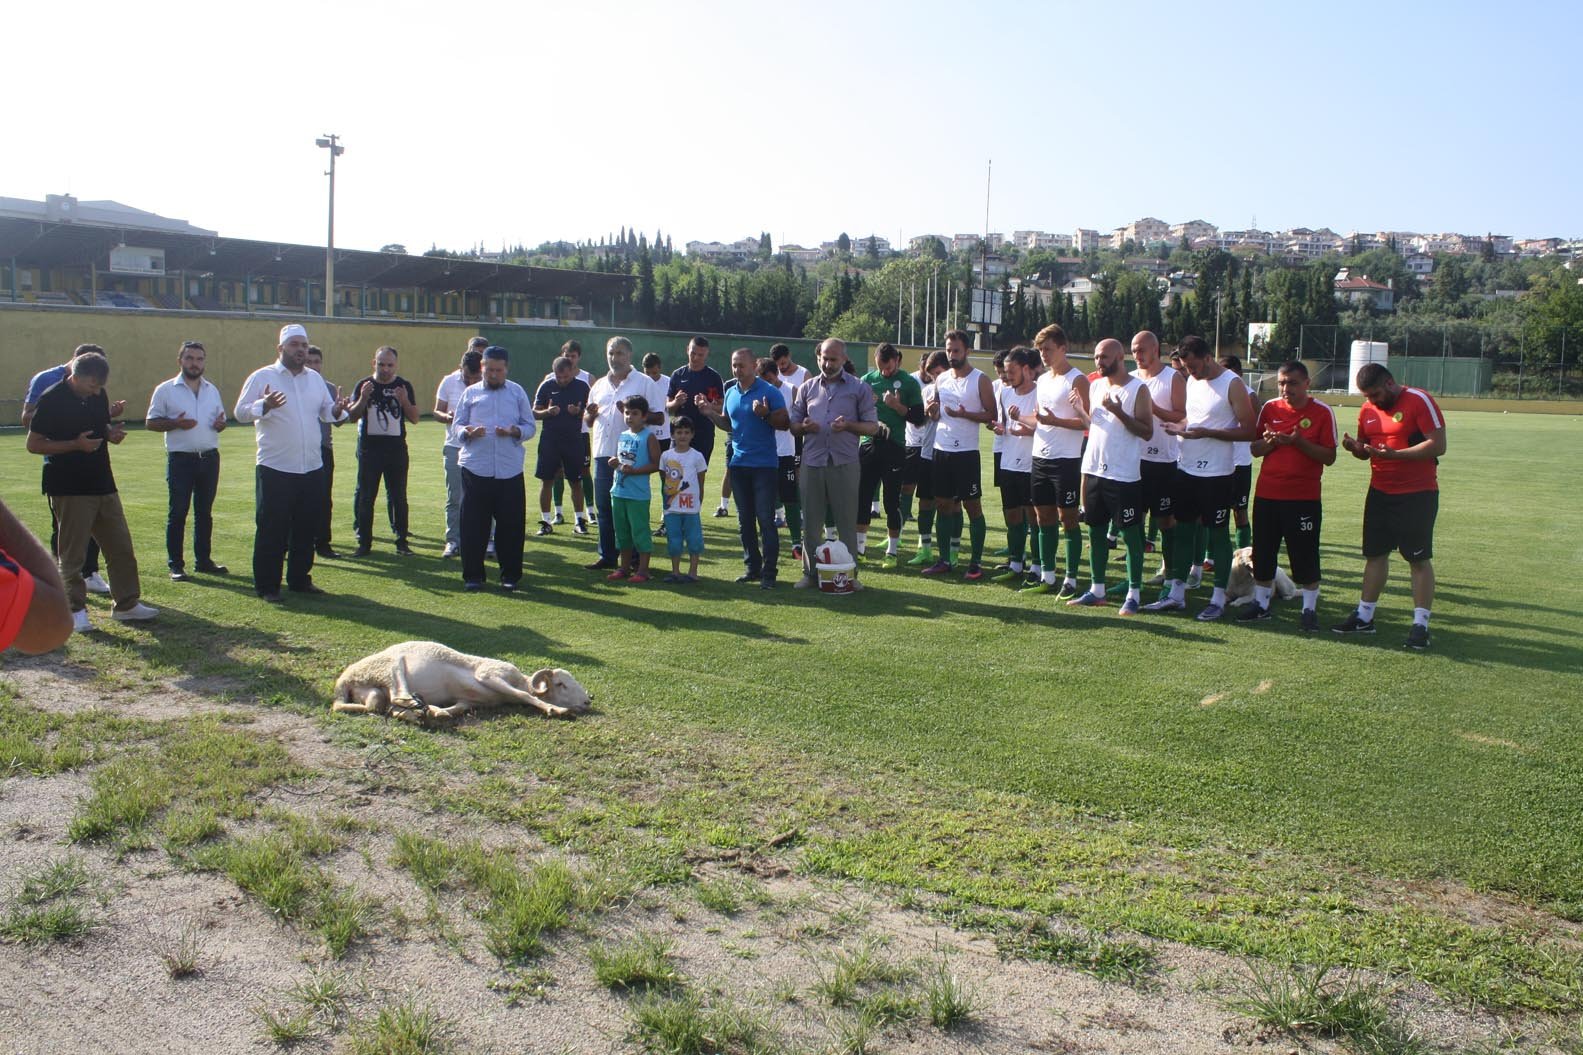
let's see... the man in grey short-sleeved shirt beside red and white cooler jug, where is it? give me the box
[788,337,880,589]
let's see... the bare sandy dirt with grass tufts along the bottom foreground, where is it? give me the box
[0,662,1551,1055]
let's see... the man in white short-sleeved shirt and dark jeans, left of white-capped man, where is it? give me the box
[144,341,226,583]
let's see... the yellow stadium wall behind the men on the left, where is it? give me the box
[0,304,490,425]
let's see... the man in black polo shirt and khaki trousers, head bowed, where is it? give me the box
[27,352,160,630]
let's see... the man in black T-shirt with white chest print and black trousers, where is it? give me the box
[347,345,418,556]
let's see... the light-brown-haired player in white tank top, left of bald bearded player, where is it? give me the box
[1024,323,1089,600]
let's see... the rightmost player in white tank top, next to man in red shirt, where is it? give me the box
[1145,336,1254,623]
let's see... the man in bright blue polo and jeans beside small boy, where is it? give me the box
[695,348,790,589]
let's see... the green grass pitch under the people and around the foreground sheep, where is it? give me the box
[0,413,1583,1015]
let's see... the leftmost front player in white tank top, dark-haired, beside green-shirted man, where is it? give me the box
[923,329,996,581]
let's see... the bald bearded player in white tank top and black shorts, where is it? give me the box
[1067,337,1154,616]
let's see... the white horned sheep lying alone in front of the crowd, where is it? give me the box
[329,642,594,726]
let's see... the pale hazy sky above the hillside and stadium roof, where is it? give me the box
[0,0,1583,252]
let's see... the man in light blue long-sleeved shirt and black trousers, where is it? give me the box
[456,344,537,592]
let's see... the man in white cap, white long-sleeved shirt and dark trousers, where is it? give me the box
[236,323,351,604]
